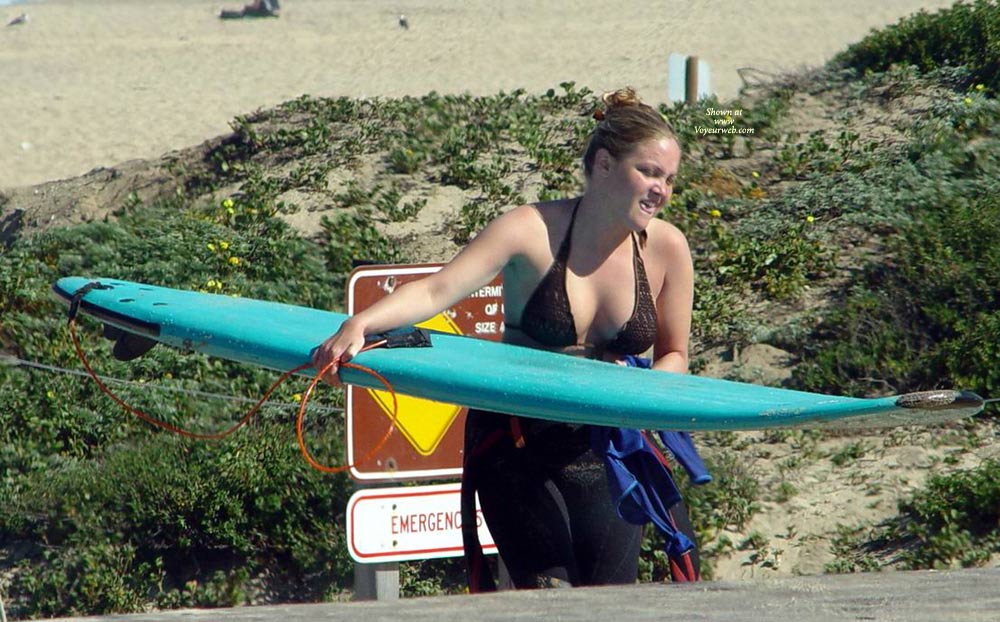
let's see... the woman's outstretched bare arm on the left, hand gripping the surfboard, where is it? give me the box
[313,205,544,383]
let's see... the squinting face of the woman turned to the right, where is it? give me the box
[608,138,681,231]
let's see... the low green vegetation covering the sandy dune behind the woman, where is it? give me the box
[0,0,1000,618]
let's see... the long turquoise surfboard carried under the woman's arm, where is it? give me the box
[53,277,983,430]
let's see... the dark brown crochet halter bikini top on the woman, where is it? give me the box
[506,201,656,354]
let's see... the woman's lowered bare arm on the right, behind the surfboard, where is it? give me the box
[650,227,694,374]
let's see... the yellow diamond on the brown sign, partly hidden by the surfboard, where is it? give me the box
[367,313,462,456]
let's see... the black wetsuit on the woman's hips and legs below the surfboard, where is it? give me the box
[463,410,641,588]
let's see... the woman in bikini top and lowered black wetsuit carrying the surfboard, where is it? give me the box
[313,89,694,589]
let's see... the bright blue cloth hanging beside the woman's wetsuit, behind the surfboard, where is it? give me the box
[590,355,712,557]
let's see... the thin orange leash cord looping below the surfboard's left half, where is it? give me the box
[68,317,399,473]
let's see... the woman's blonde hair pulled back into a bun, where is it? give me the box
[583,87,677,178]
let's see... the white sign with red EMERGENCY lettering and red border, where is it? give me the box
[347,484,496,563]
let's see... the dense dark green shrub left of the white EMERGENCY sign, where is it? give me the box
[0,423,352,615]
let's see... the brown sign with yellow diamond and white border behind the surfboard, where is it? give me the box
[346,264,503,481]
